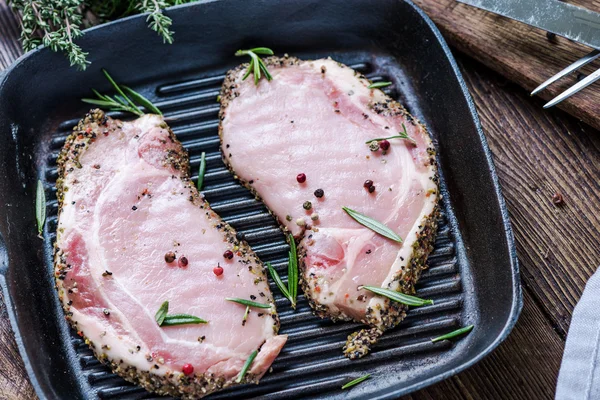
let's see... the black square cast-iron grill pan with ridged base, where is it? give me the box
[0,0,522,400]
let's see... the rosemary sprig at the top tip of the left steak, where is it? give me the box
[81,69,162,116]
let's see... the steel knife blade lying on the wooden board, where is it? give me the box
[458,0,600,49]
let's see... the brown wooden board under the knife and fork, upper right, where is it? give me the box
[414,0,600,129]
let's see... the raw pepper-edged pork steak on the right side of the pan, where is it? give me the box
[220,57,439,357]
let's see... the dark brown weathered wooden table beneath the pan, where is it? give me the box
[0,1,600,399]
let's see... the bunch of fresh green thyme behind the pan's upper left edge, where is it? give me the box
[8,0,193,69]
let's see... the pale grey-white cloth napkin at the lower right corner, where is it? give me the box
[556,271,600,400]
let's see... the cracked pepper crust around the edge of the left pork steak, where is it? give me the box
[54,109,279,399]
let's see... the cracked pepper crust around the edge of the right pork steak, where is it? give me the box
[219,54,441,359]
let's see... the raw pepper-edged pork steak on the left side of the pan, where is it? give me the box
[55,110,286,398]
